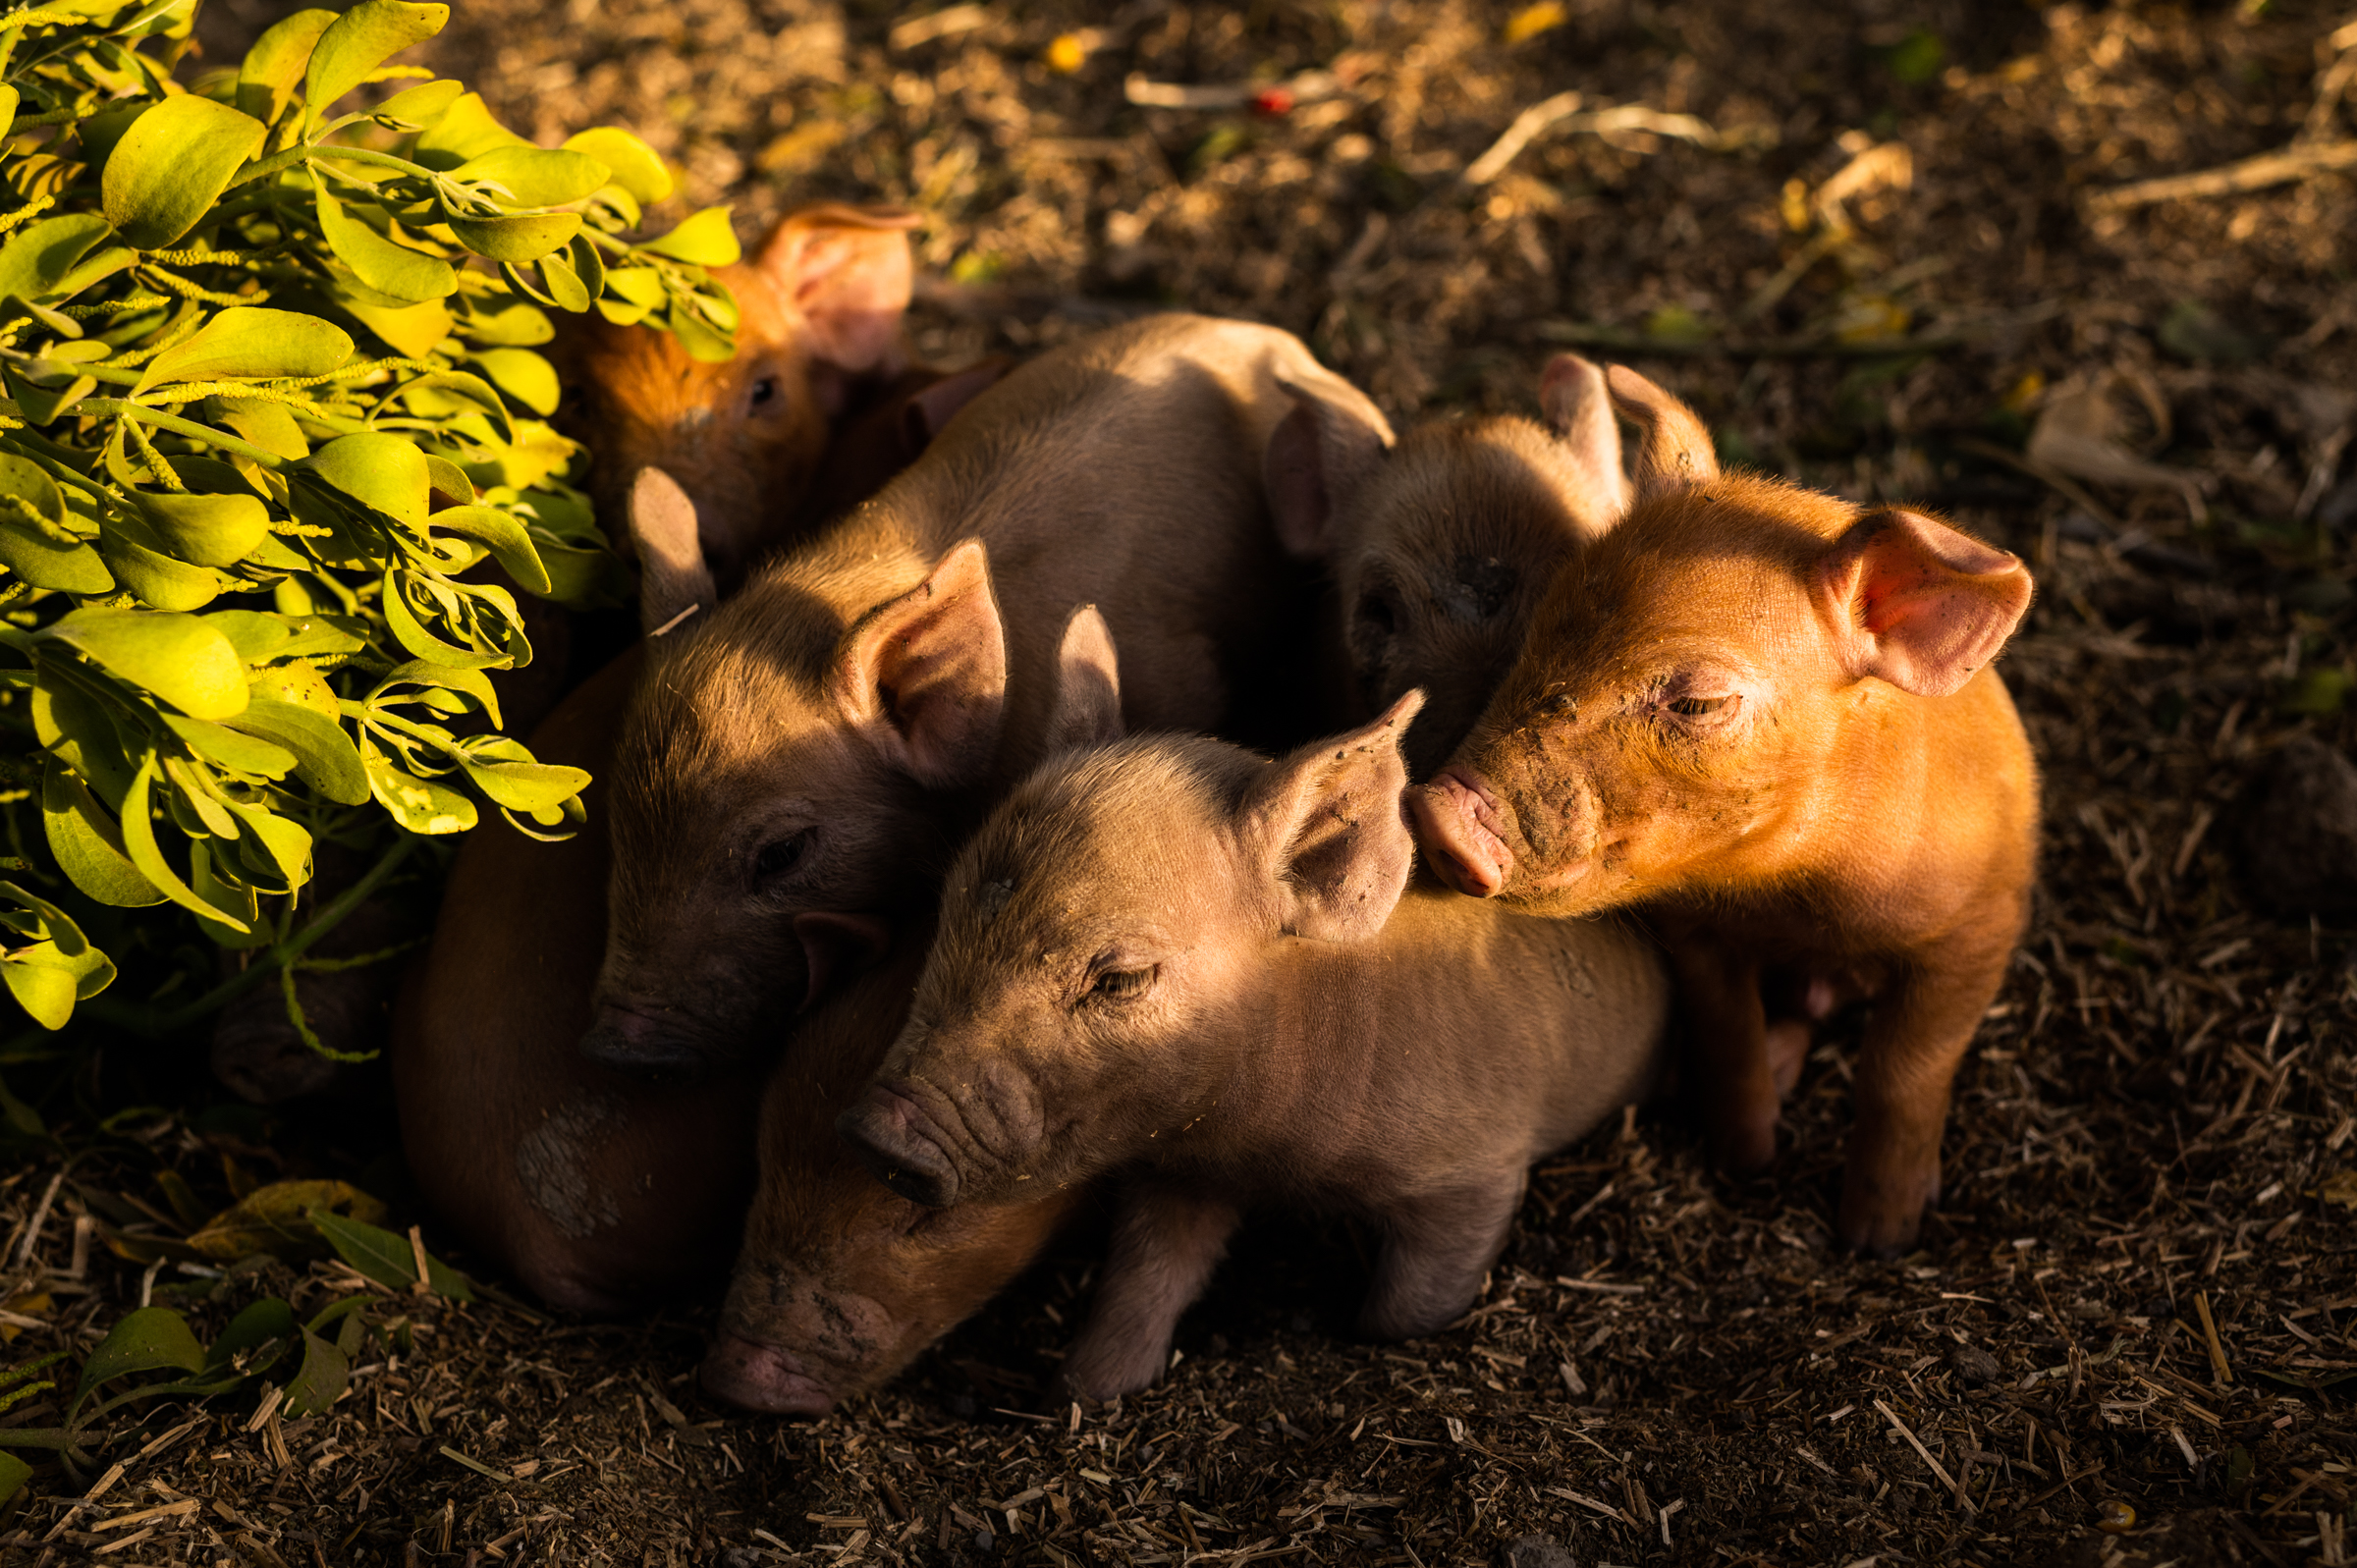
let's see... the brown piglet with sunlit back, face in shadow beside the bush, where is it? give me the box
[584,316,1381,1073]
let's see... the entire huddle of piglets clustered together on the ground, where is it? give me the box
[394,207,2037,1415]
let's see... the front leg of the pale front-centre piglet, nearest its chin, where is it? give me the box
[1059,1184,1242,1400]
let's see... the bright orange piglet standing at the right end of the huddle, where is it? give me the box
[1414,368,2039,1252]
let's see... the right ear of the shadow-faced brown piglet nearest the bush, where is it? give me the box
[835,540,1007,790]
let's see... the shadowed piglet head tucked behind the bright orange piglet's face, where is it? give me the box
[1268,353,1628,778]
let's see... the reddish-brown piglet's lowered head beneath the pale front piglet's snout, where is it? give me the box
[702,943,1082,1415]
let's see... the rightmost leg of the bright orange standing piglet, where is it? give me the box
[1838,929,2013,1257]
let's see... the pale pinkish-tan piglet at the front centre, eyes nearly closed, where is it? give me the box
[839,616,1669,1398]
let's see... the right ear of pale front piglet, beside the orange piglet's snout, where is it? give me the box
[1239,691,1424,941]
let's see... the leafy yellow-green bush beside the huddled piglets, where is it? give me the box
[0,0,738,1030]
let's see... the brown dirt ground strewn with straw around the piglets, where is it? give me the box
[0,0,2357,1568]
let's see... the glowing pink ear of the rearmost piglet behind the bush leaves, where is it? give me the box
[754,203,924,375]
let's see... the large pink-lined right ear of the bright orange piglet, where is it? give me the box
[1817,510,2032,698]
